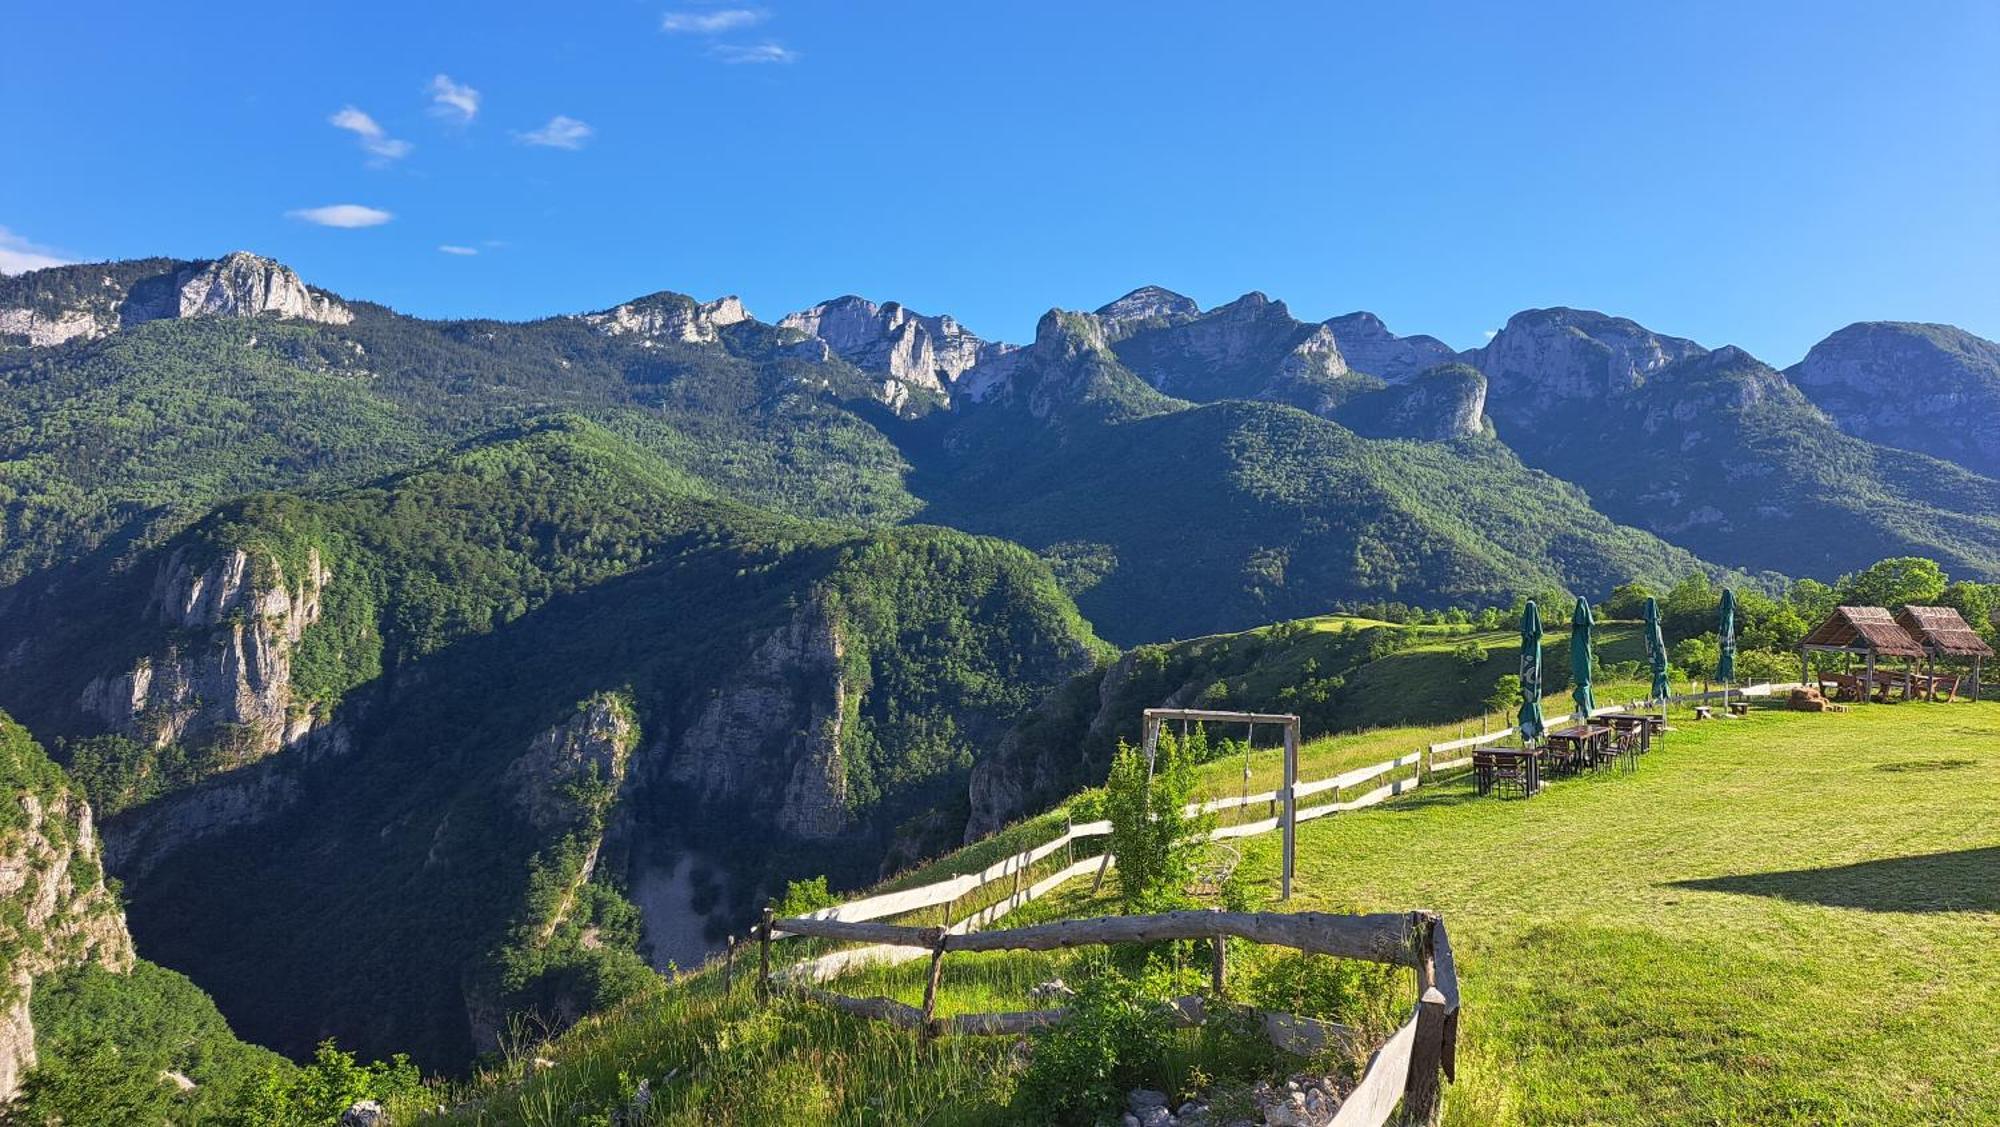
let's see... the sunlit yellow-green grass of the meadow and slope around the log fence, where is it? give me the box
[414,703,2000,1125]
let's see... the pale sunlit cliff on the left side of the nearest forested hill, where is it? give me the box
[76,548,332,765]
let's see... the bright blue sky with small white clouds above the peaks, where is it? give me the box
[0,0,2000,364]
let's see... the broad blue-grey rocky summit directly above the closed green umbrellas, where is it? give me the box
[1468,308,1708,429]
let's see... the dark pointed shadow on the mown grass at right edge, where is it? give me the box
[1670,845,2000,911]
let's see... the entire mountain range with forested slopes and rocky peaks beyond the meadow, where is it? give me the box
[0,252,2000,1067]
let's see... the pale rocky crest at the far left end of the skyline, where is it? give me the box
[0,250,354,348]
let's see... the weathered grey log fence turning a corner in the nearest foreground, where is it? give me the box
[756,911,1458,1127]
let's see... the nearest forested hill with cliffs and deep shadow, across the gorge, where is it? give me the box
[6,418,1100,1067]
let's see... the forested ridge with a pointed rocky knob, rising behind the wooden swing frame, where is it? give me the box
[914,314,1698,643]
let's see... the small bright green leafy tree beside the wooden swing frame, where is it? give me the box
[1104,731,1214,915]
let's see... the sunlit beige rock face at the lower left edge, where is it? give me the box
[0,717,132,1101]
